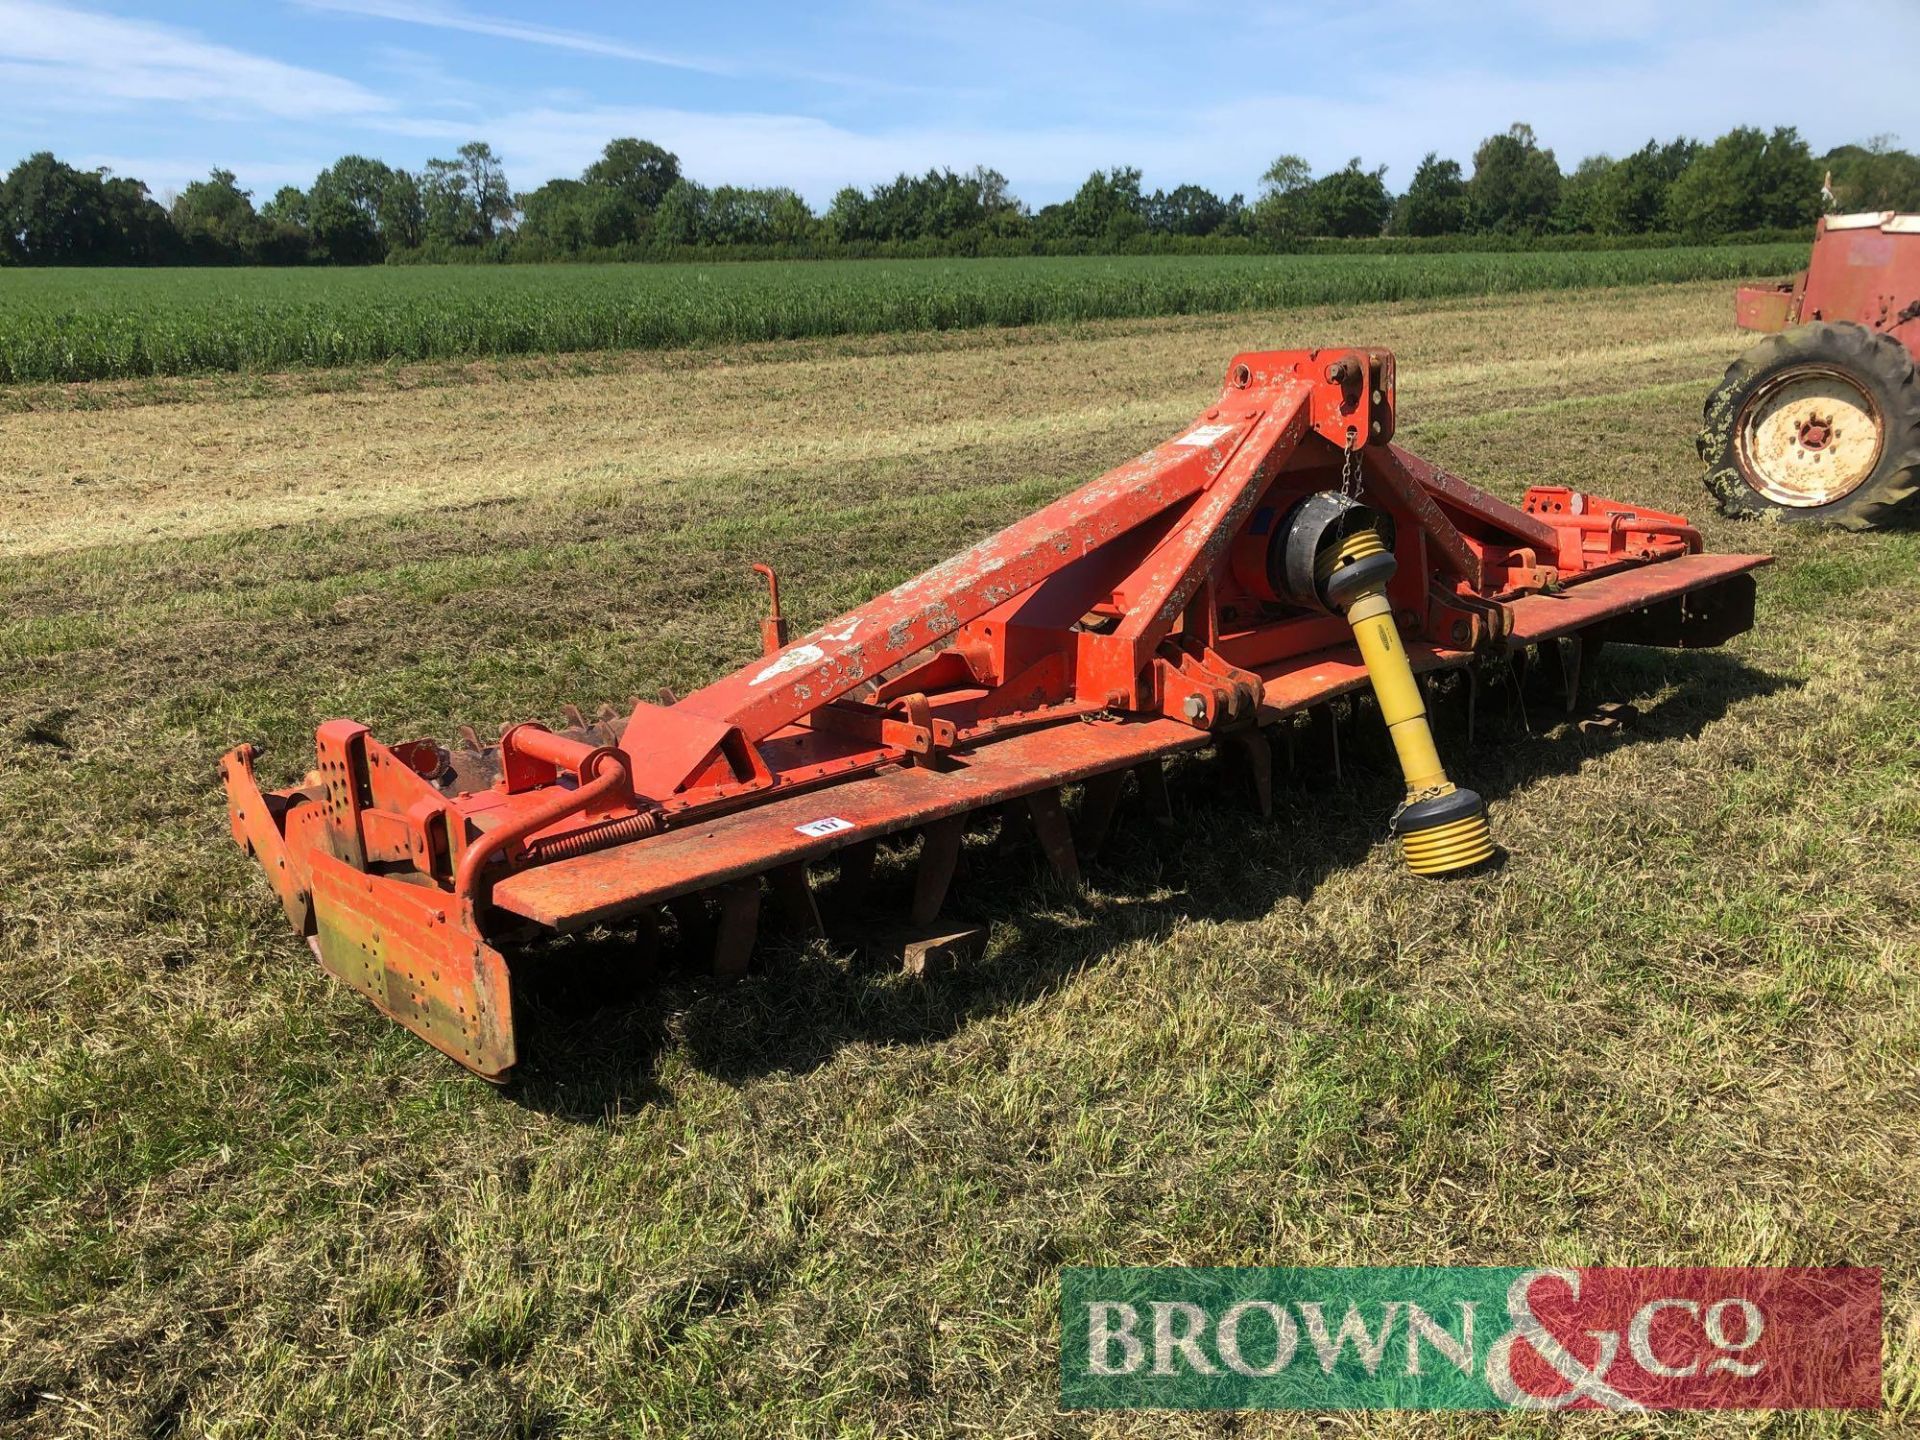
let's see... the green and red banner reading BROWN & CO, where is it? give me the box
[1060,1265,1882,1411]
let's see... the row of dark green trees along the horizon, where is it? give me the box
[0,125,1920,265]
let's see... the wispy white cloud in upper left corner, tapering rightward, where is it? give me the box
[0,0,392,121]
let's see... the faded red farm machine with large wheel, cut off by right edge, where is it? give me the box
[1699,211,1920,530]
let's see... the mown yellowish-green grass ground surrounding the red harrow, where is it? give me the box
[0,286,1920,1436]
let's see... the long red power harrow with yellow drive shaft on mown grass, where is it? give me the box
[223,349,1766,1079]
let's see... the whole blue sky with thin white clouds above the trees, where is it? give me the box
[0,0,1920,205]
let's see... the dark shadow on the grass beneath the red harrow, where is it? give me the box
[507,647,1797,1123]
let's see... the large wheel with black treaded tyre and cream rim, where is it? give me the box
[1697,321,1920,530]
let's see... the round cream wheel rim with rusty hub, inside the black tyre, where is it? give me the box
[1738,365,1885,509]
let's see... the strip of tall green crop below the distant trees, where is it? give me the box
[0,244,1807,384]
